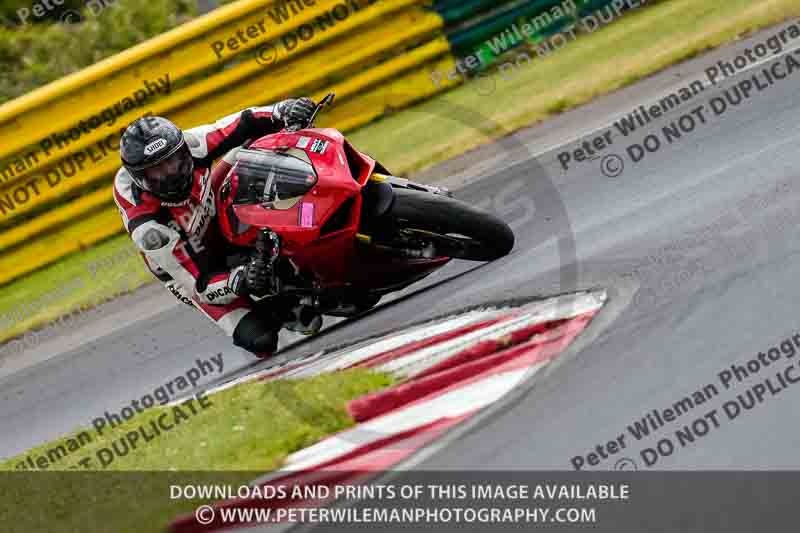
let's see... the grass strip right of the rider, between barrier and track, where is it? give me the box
[350,0,800,173]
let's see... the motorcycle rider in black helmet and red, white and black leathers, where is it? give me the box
[114,98,321,357]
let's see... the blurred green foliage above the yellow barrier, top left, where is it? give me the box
[0,0,197,104]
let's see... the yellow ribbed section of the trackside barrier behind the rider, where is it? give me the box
[0,0,449,283]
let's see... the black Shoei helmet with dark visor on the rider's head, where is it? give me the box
[119,116,194,202]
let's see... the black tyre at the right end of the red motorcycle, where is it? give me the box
[391,188,514,261]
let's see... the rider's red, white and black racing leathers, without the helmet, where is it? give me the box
[114,106,284,355]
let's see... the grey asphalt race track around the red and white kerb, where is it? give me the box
[0,19,800,478]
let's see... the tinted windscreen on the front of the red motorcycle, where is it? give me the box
[233,150,317,204]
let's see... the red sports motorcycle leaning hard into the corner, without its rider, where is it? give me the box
[216,94,514,317]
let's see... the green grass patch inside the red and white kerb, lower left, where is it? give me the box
[0,370,392,532]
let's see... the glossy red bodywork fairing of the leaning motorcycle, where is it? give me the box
[212,129,449,289]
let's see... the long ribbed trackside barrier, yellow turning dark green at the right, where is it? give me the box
[0,0,648,285]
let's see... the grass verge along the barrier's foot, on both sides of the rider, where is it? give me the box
[0,0,800,342]
